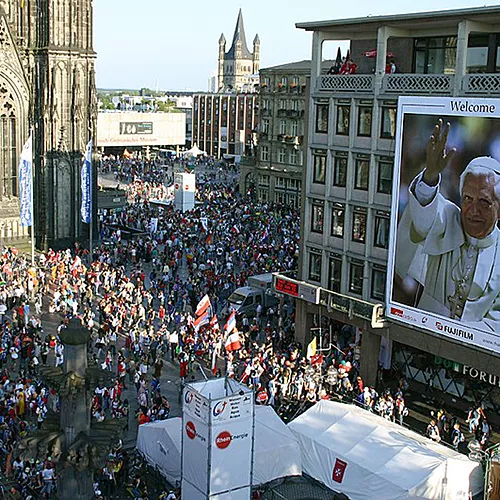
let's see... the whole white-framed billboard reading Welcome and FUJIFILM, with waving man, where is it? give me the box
[386,97,500,352]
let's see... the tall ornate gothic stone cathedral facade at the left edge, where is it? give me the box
[0,0,97,249]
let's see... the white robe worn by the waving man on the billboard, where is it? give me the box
[396,176,500,335]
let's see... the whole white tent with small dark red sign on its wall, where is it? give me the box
[288,401,483,500]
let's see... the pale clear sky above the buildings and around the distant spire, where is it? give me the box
[94,0,498,91]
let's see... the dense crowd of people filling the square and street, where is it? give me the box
[0,153,494,497]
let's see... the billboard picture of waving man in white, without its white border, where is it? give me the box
[392,115,500,335]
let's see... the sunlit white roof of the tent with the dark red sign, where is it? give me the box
[288,401,477,493]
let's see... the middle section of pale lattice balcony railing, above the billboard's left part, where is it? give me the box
[382,73,455,94]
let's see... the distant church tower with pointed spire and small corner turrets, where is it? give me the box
[217,9,260,92]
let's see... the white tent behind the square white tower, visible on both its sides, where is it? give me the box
[137,406,302,485]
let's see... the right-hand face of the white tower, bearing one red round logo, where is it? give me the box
[210,416,253,494]
